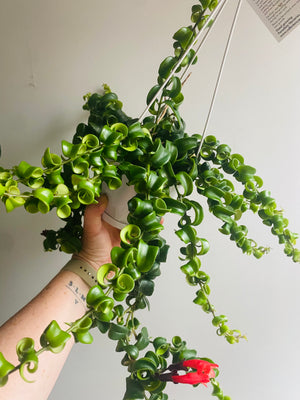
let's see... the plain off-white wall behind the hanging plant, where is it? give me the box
[0,0,300,400]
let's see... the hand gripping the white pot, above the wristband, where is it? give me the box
[73,195,120,270]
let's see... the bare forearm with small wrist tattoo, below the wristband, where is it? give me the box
[0,271,89,400]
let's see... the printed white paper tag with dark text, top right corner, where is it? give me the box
[248,0,300,42]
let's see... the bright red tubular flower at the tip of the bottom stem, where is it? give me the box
[172,359,219,386]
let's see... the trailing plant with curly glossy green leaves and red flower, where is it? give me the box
[0,0,300,400]
